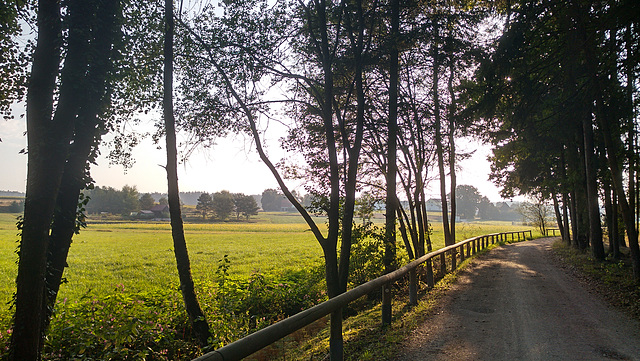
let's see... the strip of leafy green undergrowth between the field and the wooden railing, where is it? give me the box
[0,262,326,361]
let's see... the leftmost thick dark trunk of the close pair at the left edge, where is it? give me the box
[9,0,63,361]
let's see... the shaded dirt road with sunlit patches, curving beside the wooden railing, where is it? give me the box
[397,238,640,361]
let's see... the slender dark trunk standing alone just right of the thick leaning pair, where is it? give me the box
[163,0,211,346]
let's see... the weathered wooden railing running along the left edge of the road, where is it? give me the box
[194,231,532,361]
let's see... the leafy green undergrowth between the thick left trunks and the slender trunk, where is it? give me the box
[44,285,200,361]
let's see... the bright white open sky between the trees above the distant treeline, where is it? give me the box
[0,105,510,202]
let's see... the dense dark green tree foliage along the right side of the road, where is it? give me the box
[464,0,640,270]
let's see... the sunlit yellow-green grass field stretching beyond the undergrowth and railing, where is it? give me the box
[0,213,530,357]
